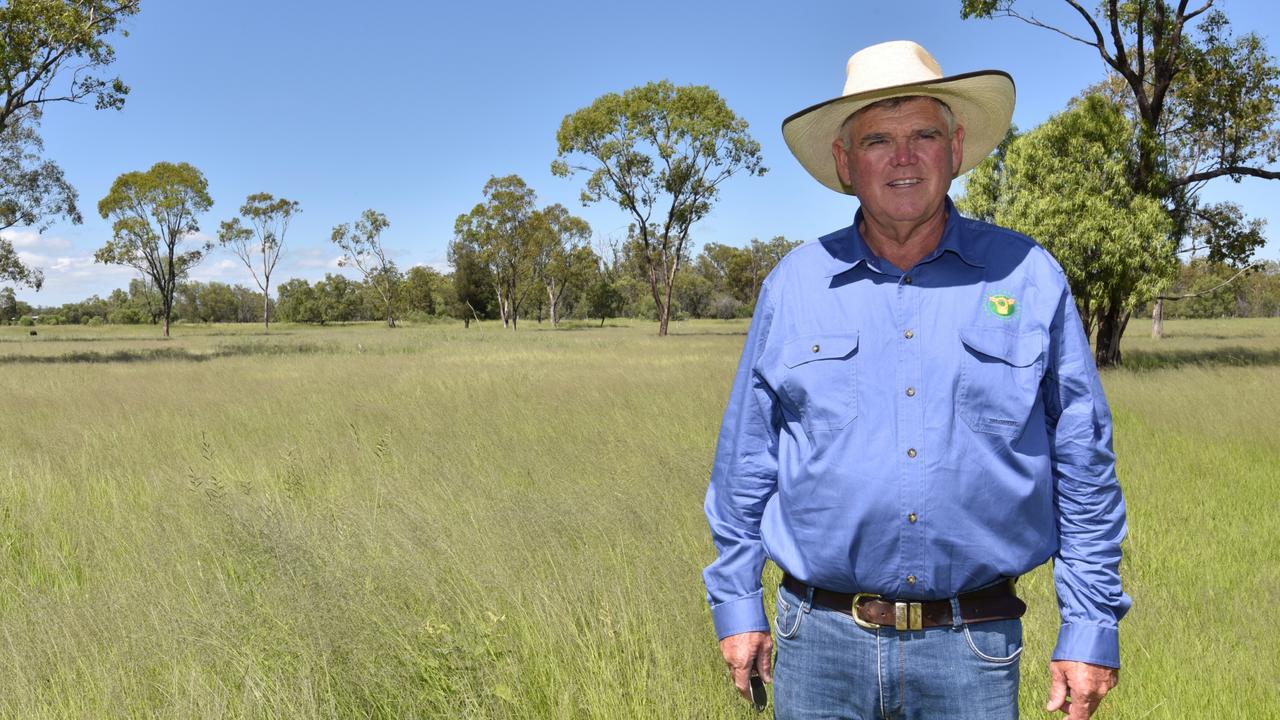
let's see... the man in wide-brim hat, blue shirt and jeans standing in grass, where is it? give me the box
[704,41,1129,720]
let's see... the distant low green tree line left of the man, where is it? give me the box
[0,237,800,324]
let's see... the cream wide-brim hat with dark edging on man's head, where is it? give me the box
[782,40,1015,195]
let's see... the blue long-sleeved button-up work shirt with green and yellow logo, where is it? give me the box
[704,199,1130,667]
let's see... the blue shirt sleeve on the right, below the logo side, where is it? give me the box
[1044,283,1132,667]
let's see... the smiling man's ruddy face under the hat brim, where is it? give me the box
[831,97,964,229]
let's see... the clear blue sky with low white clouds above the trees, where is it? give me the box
[5,0,1280,305]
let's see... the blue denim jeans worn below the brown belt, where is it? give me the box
[773,579,1023,720]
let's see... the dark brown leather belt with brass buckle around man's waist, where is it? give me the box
[782,575,1027,630]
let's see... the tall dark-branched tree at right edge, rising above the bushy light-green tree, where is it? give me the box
[961,0,1280,356]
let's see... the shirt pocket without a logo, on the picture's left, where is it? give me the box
[782,332,858,432]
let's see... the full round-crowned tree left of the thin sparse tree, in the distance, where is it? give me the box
[93,163,214,337]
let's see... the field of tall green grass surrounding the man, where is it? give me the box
[0,320,1280,719]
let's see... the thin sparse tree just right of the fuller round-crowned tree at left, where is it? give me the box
[218,192,302,331]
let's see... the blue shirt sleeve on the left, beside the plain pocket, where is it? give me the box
[703,283,781,639]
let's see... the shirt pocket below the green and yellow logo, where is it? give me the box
[956,328,1047,437]
